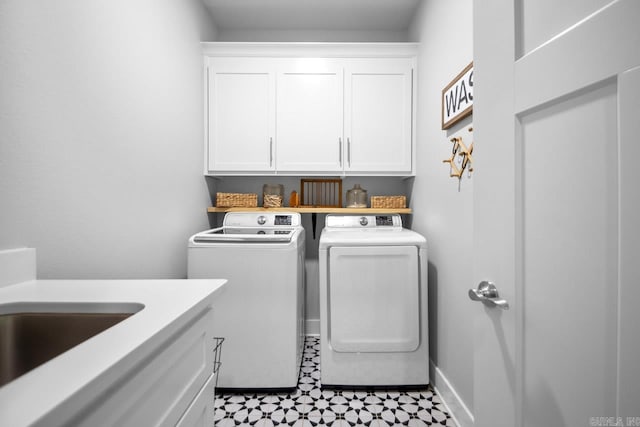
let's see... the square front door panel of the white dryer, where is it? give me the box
[327,246,420,352]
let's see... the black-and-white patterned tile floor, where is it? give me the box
[215,337,455,427]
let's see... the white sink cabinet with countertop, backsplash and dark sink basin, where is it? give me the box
[0,248,226,427]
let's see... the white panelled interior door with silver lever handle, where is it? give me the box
[470,0,640,427]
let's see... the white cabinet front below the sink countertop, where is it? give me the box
[73,309,215,427]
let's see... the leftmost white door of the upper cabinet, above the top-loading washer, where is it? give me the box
[206,58,275,172]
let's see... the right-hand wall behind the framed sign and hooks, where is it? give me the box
[410,0,482,425]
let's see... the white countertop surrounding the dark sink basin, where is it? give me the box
[0,279,226,426]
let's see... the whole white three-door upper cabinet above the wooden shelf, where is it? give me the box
[203,43,416,176]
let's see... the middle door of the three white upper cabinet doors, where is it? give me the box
[276,58,344,173]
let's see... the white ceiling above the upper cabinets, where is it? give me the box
[203,0,420,31]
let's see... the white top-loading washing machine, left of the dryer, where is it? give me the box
[188,212,305,391]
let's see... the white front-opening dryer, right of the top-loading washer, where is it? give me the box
[319,215,429,388]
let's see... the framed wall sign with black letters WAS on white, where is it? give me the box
[442,62,473,129]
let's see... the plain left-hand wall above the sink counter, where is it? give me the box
[0,0,215,278]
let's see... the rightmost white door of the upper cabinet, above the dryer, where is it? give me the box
[345,58,413,174]
